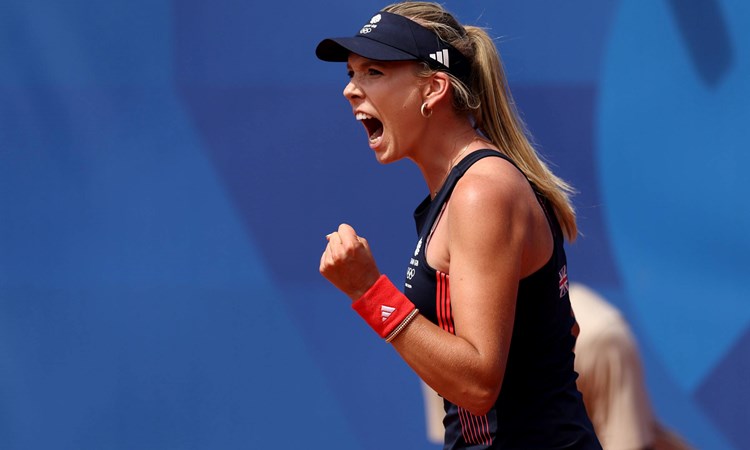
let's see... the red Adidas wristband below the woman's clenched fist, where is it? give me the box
[352,275,415,339]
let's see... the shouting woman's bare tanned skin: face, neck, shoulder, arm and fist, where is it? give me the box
[320,54,553,415]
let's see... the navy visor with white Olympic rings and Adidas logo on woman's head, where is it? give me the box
[315,11,471,82]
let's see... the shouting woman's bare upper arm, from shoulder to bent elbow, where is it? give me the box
[447,167,530,391]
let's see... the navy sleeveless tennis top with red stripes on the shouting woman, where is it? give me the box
[404,150,601,450]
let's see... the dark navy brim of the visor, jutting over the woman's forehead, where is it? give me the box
[315,36,419,62]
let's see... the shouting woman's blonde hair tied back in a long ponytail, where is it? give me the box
[383,2,578,242]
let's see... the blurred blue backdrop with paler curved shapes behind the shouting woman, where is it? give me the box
[0,0,750,450]
